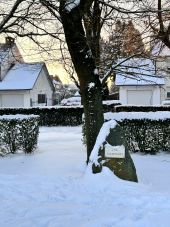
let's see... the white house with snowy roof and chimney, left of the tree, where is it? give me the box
[0,37,54,107]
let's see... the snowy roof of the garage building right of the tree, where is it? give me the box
[115,58,165,86]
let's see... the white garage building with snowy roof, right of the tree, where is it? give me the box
[115,58,165,105]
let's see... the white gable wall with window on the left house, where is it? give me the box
[30,69,53,106]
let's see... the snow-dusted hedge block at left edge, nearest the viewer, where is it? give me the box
[0,115,39,155]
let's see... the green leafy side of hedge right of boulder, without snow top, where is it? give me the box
[119,119,170,154]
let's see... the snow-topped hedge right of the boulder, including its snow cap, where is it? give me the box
[105,111,170,154]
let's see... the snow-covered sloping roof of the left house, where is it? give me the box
[0,63,44,90]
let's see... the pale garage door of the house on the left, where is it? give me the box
[1,95,24,107]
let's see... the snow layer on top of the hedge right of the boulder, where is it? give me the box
[104,111,170,121]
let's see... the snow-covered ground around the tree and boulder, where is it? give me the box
[0,127,170,227]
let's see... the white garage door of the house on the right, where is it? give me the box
[127,90,152,105]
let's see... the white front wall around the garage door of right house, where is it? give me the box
[119,86,162,105]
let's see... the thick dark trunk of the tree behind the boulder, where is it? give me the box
[60,1,104,163]
